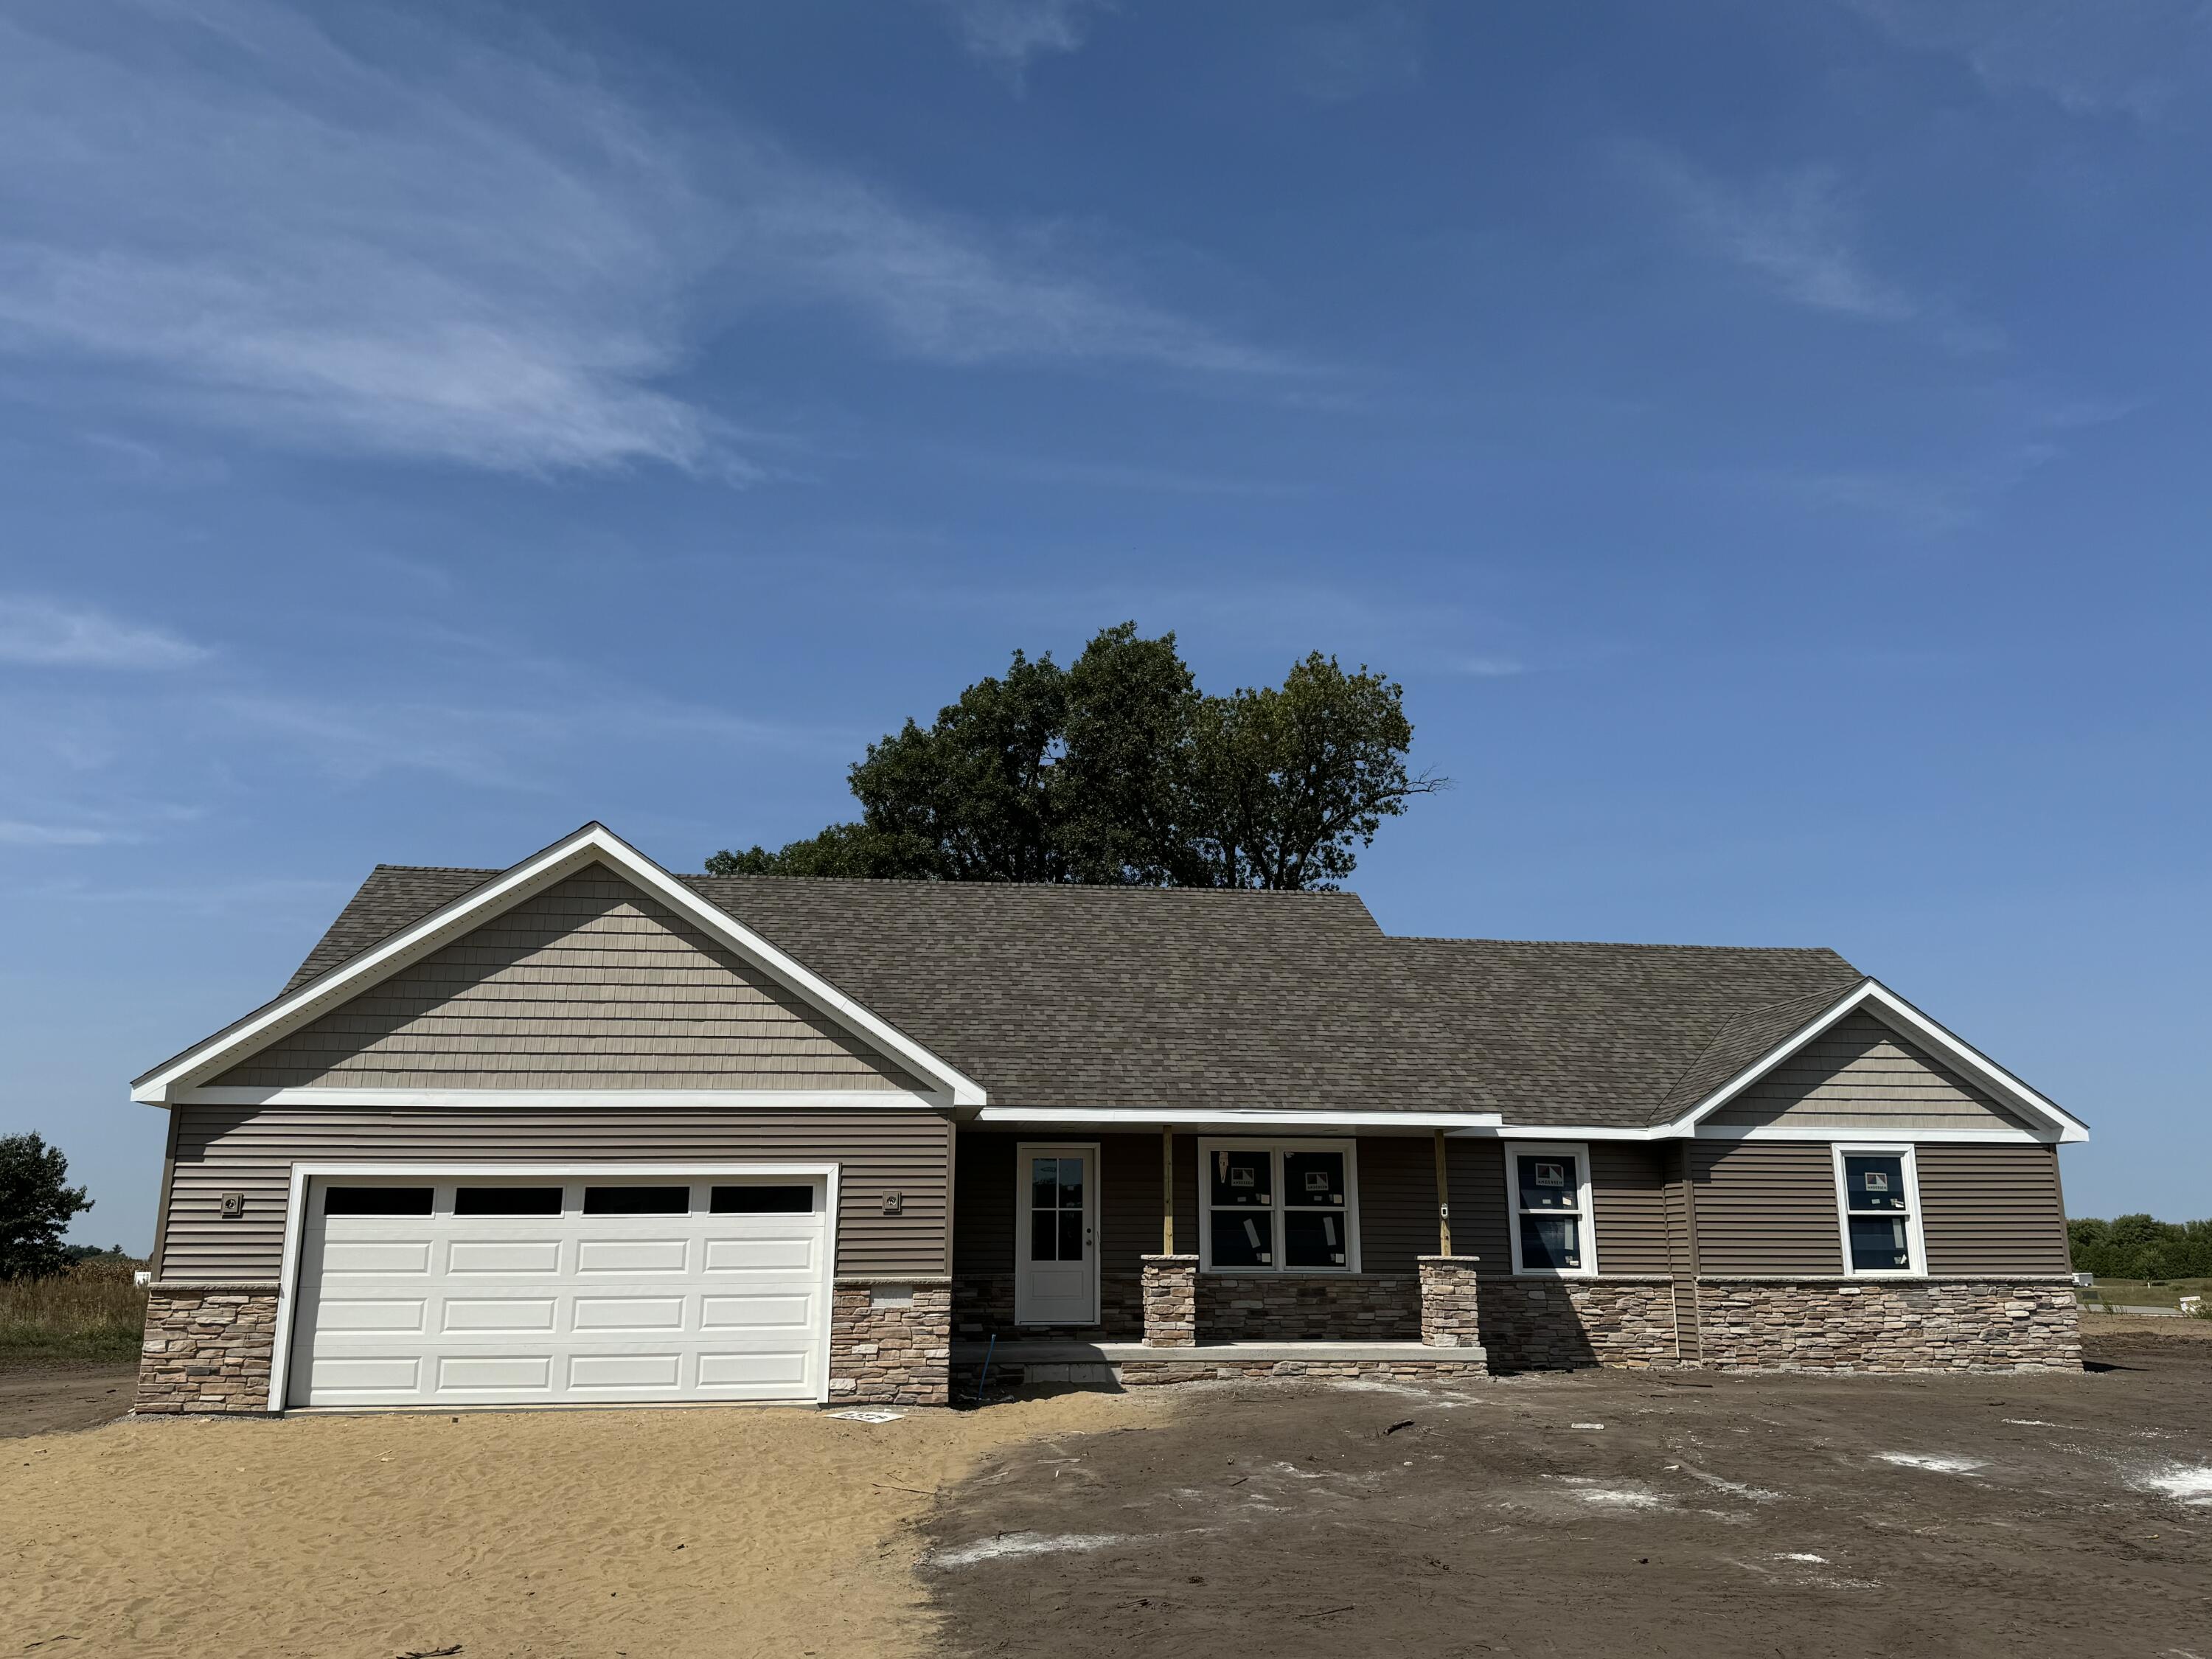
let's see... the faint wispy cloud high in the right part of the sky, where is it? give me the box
[1624,144,2000,352]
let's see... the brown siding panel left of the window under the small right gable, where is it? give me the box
[1681,1141,1843,1276]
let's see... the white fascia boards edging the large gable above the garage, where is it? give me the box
[131,823,987,1106]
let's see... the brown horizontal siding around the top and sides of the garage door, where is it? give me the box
[161,1106,951,1281]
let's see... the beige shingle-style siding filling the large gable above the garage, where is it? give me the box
[208,865,920,1091]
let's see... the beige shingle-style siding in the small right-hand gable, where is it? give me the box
[1705,1013,2024,1137]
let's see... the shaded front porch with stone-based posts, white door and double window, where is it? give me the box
[953,1124,1486,1380]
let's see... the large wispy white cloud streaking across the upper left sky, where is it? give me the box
[0,0,1283,478]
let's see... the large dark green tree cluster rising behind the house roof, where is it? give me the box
[708,622,1444,887]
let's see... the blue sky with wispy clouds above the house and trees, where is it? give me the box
[0,0,2212,1248]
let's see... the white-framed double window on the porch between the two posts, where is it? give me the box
[1199,1141,1358,1274]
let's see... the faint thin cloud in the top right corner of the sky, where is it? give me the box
[1843,0,2212,119]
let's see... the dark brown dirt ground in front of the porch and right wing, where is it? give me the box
[922,1321,2212,1659]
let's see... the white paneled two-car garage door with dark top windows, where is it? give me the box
[285,1172,832,1407]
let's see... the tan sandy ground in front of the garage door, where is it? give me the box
[0,1394,1168,1659]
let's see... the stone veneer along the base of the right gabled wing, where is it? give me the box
[1699,1279,2081,1371]
